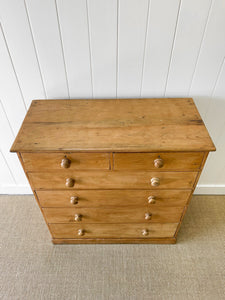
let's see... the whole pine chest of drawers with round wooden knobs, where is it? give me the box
[11,98,215,244]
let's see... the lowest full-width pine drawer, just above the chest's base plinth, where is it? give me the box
[49,223,178,239]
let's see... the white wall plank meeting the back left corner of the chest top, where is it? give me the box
[0,0,45,107]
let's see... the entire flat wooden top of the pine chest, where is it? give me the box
[11,98,215,152]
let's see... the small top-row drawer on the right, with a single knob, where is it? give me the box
[113,152,204,171]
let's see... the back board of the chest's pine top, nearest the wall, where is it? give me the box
[22,98,201,123]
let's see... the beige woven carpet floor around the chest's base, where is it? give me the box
[0,196,225,300]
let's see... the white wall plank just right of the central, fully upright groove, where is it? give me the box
[117,0,149,98]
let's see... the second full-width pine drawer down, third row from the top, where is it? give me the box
[36,190,192,208]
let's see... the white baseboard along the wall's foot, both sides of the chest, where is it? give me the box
[0,184,225,195]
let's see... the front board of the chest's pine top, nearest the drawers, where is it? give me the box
[12,123,214,152]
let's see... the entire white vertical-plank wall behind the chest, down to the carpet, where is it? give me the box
[0,0,225,194]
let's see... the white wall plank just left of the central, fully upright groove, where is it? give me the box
[87,0,117,98]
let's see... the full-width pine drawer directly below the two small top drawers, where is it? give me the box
[28,171,197,190]
